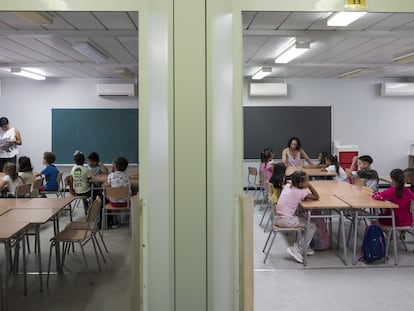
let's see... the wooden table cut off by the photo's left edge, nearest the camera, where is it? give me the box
[0,221,29,310]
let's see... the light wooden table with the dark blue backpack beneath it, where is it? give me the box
[311,180,398,265]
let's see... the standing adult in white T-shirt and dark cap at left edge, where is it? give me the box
[0,117,22,171]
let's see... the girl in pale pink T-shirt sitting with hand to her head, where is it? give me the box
[275,171,319,263]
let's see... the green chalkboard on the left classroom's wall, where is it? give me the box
[52,109,138,164]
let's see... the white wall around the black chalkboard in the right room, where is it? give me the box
[243,79,414,180]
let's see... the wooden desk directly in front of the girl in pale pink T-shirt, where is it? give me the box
[300,195,351,266]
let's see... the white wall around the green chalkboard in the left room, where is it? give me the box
[0,79,138,171]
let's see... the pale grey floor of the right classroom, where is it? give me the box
[254,202,414,311]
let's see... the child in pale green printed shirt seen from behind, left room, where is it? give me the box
[70,151,92,214]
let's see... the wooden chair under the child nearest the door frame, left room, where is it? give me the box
[102,186,131,234]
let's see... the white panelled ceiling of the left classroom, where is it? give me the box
[0,11,138,80]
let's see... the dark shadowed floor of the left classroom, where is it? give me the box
[1,208,131,311]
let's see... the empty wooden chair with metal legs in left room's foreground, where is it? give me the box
[46,199,102,285]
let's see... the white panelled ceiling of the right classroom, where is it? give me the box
[243,12,414,79]
